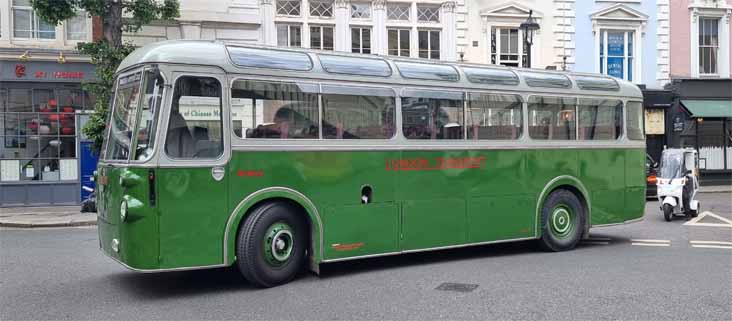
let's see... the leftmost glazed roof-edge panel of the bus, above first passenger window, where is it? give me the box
[226,46,313,71]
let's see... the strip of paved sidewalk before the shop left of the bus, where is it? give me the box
[0,205,97,228]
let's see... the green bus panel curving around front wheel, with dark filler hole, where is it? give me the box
[230,151,399,259]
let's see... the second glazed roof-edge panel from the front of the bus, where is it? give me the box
[318,55,391,77]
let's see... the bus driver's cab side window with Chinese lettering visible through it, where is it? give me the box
[165,76,224,159]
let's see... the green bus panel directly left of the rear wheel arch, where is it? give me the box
[467,150,536,243]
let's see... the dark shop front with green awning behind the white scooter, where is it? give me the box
[669,79,732,185]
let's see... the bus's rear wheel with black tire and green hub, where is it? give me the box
[539,189,587,252]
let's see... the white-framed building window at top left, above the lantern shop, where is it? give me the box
[12,0,56,39]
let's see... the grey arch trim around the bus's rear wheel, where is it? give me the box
[535,175,592,238]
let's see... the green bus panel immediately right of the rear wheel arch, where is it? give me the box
[579,149,625,225]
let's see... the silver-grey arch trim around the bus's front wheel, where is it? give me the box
[223,187,322,273]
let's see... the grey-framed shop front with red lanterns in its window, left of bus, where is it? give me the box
[0,60,94,207]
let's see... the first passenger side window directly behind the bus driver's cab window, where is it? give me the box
[231,80,319,139]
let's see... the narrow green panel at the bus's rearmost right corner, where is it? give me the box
[624,149,646,220]
